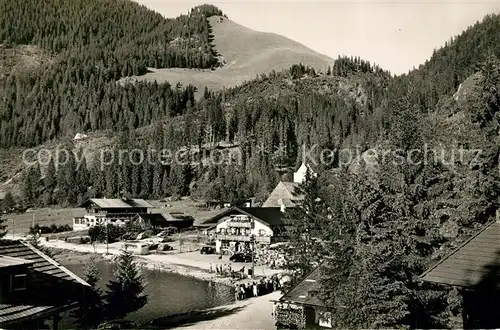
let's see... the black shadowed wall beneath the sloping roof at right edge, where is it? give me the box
[462,250,500,329]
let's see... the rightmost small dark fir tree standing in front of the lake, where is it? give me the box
[105,251,147,319]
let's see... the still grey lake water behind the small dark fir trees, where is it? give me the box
[61,261,234,328]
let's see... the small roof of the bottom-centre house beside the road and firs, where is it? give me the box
[279,267,324,307]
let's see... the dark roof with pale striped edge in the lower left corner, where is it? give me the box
[0,239,90,327]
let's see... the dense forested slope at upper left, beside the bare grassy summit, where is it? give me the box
[0,0,222,147]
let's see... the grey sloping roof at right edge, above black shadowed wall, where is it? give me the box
[421,222,500,287]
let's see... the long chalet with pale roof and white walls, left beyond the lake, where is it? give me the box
[73,198,153,230]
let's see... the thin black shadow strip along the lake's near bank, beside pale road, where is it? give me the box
[141,306,243,329]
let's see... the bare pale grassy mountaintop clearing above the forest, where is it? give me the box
[121,16,333,96]
